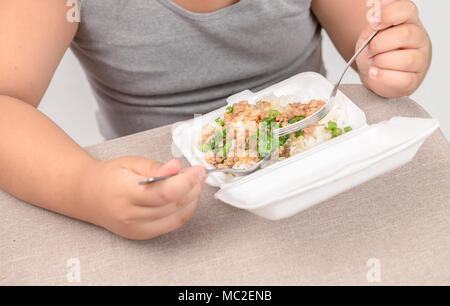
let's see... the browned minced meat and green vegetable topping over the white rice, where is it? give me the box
[201,100,328,168]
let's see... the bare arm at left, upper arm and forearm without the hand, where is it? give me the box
[0,0,90,213]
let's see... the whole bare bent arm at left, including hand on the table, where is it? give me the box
[0,0,206,239]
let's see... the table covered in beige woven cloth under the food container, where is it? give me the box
[0,85,450,285]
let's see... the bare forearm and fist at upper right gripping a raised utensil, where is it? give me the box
[312,0,432,98]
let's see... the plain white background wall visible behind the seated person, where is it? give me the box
[39,0,450,146]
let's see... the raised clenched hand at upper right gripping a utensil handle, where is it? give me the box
[356,0,432,98]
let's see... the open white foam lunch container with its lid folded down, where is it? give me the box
[172,72,439,220]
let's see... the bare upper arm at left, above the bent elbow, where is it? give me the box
[0,0,78,107]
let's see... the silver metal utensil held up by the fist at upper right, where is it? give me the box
[274,31,379,137]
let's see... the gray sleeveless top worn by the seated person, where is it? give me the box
[71,0,324,139]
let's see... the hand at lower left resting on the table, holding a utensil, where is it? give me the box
[75,156,206,240]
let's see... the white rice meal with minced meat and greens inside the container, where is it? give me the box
[201,95,351,169]
